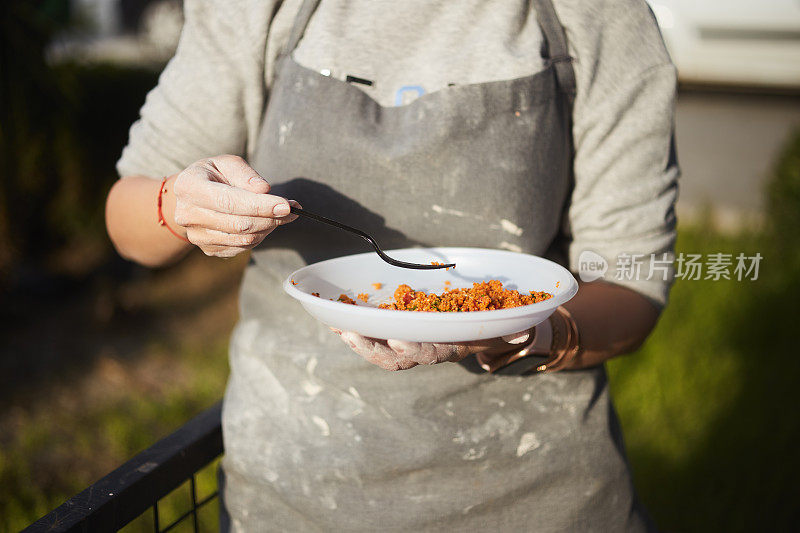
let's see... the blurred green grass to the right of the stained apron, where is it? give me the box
[608,222,800,531]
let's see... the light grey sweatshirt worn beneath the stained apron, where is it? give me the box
[117,0,678,306]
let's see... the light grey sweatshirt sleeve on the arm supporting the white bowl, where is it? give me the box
[556,0,679,308]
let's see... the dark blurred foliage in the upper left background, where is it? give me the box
[0,0,158,291]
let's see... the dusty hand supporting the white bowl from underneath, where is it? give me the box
[331,328,531,370]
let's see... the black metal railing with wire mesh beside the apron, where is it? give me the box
[24,402,223,533]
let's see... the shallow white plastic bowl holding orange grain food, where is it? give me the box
[283,248,578,342]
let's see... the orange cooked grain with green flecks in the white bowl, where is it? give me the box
[378,279,553,313]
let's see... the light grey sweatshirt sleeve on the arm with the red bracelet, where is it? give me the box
[117,0,260,177]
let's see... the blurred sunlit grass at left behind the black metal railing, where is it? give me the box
[0,324,228,532]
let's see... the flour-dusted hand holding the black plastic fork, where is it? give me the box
[173,155,299,257]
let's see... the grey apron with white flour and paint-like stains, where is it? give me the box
[217,0,650,531]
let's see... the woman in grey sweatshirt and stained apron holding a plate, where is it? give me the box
[107,0,677,531]
